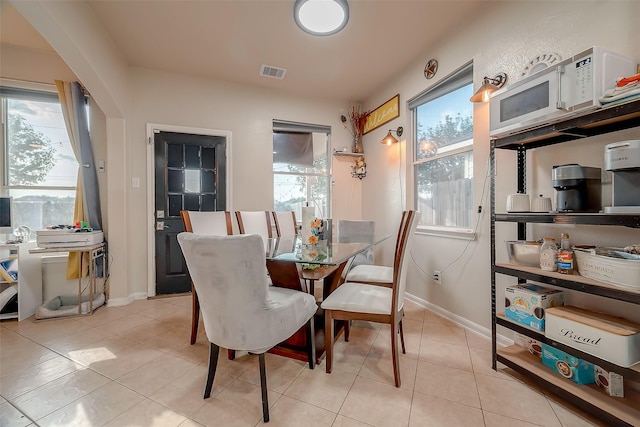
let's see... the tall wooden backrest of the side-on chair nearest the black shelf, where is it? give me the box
[392,210,420,313]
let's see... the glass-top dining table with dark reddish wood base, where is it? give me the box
[265,234,391,369]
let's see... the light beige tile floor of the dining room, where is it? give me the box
[0,296,600,427]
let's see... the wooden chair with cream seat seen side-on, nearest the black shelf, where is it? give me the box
[321,211,419,387]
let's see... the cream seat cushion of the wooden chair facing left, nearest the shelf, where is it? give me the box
[321,282,392,314]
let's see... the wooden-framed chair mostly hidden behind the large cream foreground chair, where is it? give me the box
[180,211,234,350]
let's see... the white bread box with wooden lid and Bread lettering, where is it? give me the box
[545,306,640,367]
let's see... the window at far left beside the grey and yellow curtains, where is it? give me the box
[0,87,78,239]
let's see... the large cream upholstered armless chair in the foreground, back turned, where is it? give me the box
[178,233,317,422]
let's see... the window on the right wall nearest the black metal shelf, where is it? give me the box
[409,64,473,230]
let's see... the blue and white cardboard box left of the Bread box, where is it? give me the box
[504,283,564,331]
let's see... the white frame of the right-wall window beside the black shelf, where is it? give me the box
[408,61,476,236]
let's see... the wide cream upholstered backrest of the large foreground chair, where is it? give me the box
[178,233,273,351]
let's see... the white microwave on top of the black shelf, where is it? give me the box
[489,47,637,137]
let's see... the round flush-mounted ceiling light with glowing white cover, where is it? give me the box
[293,0,349,36]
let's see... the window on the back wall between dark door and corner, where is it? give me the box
[273,121,331,219]
